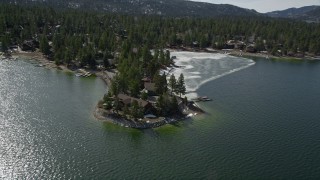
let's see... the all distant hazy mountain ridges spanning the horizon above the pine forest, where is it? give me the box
[2,0,320,22]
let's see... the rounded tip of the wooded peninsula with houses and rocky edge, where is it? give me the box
[94,65,203,129]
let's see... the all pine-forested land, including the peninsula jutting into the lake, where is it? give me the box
[0,3,320,128]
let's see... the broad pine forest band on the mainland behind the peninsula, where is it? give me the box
[0,4,320,66]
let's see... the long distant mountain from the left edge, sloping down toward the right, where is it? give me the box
[2,0,261,17]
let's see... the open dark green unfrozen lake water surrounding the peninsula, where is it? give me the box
[0,56,320,179]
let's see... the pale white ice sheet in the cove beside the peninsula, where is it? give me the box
[170,51,255,98]
